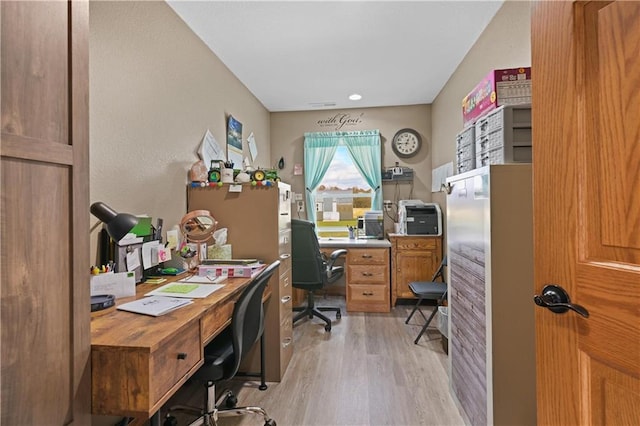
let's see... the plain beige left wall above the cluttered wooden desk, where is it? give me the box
[90,1,271,259]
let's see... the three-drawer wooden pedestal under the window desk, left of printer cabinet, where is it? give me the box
[346,248,390,312]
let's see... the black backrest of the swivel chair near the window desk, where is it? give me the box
[291,219,327,286]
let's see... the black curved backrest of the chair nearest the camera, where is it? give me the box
[226,260,280,378]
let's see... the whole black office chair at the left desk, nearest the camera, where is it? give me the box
[164,260,280,426]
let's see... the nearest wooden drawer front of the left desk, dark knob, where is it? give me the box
[149,322,202,410]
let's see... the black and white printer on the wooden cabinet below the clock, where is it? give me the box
[398,200,442,236]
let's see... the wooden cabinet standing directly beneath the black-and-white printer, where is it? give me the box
[389,234,442,305]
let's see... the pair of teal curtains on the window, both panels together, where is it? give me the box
[304,130,382,223]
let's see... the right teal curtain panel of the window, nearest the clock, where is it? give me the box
[342,130,382,210]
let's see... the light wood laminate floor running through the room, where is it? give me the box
[158,296,464,426]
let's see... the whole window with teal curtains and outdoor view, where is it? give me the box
[304,130,382,237]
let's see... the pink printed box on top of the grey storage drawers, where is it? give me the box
[462,67,531,127]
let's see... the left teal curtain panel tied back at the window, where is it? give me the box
[304,132,340,223]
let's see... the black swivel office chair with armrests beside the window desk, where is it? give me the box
[291,219,347,331]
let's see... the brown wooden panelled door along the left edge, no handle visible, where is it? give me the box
[0,1,91,426]
